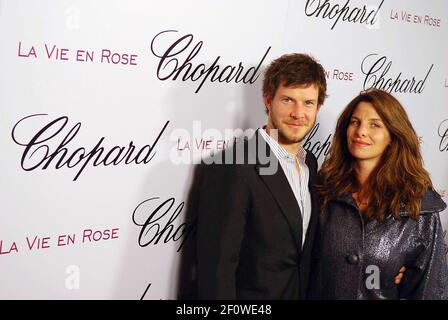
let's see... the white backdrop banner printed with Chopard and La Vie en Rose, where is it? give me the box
[0,0,448,299]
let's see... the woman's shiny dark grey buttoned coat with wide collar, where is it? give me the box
[309,191,448,299]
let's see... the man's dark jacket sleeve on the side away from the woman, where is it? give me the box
[197,165,250,299]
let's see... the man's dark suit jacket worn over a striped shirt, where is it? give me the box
[197,129,318,299]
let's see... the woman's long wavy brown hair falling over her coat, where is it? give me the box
[318,89,433,221]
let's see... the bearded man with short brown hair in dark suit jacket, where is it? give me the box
[197,54,326,299]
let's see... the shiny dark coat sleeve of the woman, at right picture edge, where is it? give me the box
[402,213,448,300]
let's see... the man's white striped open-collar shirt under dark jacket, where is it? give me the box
[259,126,311,247]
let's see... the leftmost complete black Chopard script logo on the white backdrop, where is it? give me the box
[11,114,169,181]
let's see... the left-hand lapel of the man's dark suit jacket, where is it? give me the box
[255,129,302,252]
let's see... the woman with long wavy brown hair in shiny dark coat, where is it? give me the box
[309,89,448,299]
